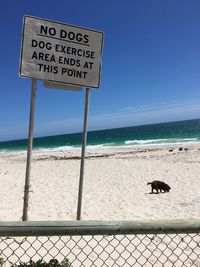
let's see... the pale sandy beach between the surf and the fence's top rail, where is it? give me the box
[0,144,200,221]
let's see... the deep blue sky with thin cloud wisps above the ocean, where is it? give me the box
[0,0,200,141]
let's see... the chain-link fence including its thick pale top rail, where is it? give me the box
[0,220,200,267]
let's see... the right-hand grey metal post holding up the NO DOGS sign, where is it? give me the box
[76,88,90,220]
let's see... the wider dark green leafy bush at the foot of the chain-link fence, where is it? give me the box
[12,259,71,267]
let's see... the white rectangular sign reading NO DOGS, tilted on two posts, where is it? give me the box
[20,16,103,88]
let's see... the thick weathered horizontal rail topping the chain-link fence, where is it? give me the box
[0,219,200,239]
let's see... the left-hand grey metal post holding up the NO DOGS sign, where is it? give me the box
[22,79,36,221]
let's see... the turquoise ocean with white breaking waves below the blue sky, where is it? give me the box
[0,119,200,152]
